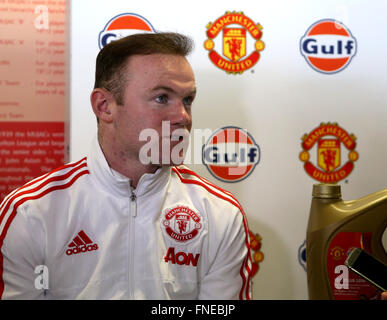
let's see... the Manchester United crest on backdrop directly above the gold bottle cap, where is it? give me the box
[300,122,359,183]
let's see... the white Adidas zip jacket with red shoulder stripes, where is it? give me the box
[0,139,252,299]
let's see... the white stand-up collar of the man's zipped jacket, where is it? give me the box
[87,136,171,197]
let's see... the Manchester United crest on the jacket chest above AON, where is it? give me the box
[162,206,203,242]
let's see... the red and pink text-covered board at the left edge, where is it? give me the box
[0,0,68,201]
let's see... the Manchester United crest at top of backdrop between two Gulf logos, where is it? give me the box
[204,11,265,74]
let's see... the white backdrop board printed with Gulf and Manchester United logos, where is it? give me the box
[69,0,387,299]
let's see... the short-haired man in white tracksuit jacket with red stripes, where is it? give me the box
[0,33,252,299]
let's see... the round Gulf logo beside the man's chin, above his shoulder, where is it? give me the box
[202,126,260,182]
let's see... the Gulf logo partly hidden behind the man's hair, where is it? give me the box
[98,13,155,49]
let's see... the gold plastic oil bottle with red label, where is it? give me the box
[306,184,387,300]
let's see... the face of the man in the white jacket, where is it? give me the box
[113,54,196,165]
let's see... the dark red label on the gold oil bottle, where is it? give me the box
[327,232,378,300]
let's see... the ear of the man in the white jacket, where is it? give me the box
[90,88,115,123]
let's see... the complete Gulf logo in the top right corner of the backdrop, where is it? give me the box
[300,19,357,74]
